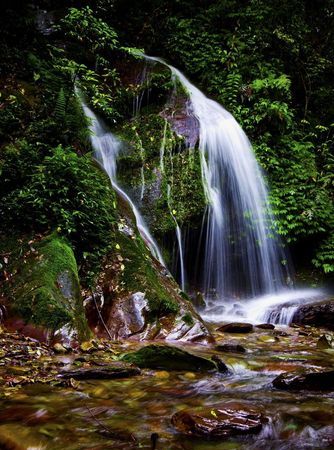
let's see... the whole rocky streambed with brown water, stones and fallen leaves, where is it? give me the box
[0,324,334,450]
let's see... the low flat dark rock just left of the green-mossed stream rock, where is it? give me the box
[58,361,140,380]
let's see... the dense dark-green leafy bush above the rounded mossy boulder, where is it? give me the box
[0,142,115,282]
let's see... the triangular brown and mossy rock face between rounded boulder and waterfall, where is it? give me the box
[85,216,213,342]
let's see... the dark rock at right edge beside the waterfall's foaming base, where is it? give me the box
[292,299,334,330]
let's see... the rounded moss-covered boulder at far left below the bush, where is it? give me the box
[1,233,90,340]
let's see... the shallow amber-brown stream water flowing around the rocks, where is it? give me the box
[0,326,334,450]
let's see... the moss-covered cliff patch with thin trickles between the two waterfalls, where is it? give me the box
[118,111,206,237]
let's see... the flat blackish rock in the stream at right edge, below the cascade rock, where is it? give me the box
[273,370,334,391]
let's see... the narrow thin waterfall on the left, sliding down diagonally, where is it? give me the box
[81,100,165,266]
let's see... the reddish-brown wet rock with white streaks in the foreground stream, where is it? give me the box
[172,402,268,438]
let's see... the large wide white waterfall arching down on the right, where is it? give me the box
[146,57,288,300]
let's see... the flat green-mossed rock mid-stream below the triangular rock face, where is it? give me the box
[122,344,217,372]
